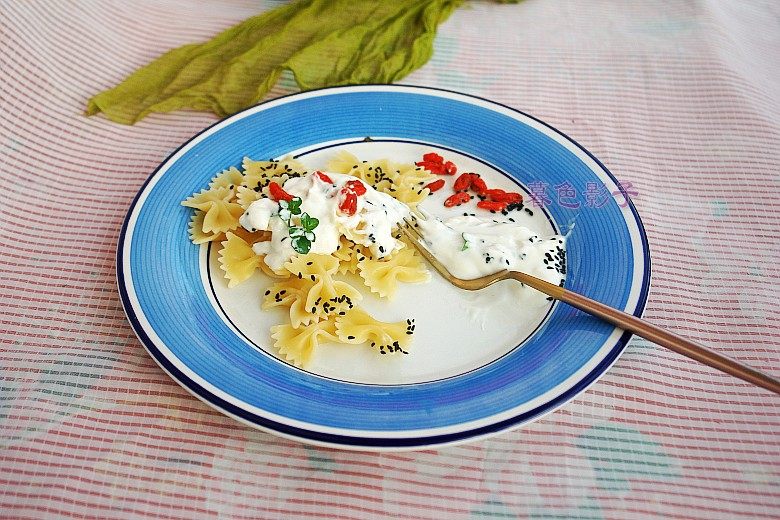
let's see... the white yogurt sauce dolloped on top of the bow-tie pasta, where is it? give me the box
[239,172,409,271]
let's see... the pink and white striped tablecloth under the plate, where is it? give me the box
[0,0,780,519]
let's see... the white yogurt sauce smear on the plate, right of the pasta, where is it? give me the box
[418,215,566,301]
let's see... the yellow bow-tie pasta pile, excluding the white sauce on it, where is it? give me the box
[182,151,434,367]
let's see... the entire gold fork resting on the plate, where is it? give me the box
[399,219,780,394]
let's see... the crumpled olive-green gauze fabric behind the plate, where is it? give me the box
[87,0,462,124]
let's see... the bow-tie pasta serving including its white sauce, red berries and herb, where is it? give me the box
[182,152,435,366]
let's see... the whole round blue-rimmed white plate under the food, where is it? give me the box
[117,86,649,449]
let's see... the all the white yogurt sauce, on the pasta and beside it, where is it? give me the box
[239,172,566,303]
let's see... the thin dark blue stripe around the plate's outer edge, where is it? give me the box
[116,84,651,448]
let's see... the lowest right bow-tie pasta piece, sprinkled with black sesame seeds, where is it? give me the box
[336,307,415,354]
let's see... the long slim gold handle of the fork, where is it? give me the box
[510,271,780,394]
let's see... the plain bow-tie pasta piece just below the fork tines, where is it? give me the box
[358,247,430,298]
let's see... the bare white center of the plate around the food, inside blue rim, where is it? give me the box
[201,138,557,385]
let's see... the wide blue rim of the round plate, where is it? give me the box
[117,85,650,450]
